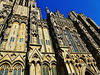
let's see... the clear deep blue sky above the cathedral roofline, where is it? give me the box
[36,0,100,27]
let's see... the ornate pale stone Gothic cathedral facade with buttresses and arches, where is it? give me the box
[0,0,100,75]
